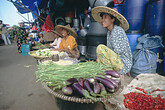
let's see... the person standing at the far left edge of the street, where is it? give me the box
[0,20,11,45]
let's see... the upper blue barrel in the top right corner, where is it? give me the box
[145,0,165,36]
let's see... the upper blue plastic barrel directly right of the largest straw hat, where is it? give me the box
[123,0,148,32]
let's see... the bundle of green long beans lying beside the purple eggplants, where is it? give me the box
[36,61,109,89]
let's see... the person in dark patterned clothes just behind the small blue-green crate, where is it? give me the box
[17,21,27,53]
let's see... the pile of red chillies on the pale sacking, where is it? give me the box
[124,87,165,110]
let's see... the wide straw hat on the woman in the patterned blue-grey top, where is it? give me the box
[92,6,129,31]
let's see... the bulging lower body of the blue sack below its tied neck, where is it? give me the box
[131,48,157,77]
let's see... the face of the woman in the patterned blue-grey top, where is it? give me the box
[101,14,115,28]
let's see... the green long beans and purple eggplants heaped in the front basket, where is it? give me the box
[36,61,120,100]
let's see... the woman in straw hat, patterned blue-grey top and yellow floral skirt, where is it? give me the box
[92,3,132,76]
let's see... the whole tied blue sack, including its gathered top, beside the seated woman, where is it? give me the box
[131,34,163,77]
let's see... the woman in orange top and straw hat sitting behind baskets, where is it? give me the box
[53,25,80,58]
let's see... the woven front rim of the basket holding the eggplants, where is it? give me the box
[42,83,124,104]
